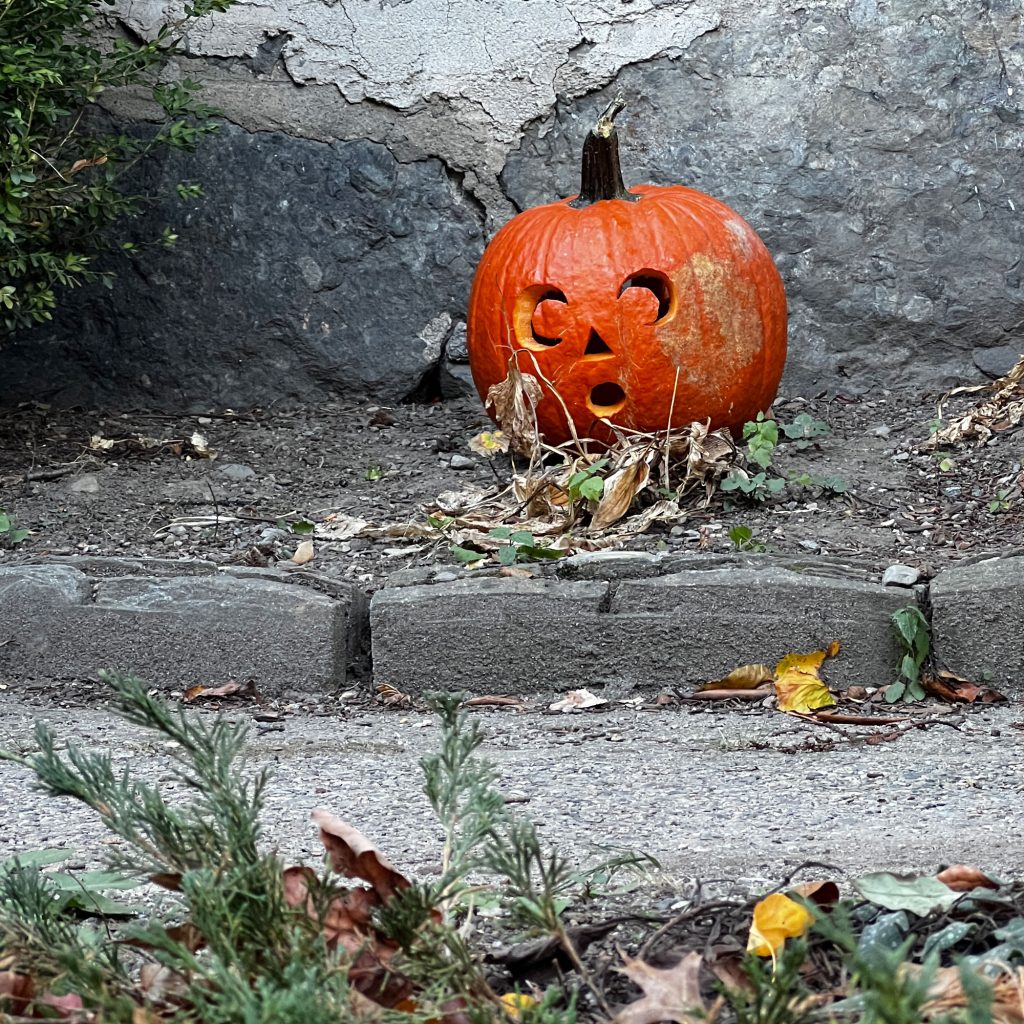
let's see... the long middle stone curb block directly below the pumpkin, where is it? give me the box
[370,559,918,693]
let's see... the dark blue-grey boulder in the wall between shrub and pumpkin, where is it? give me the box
[0,126,483,410]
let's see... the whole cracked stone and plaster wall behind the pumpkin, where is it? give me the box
[0,0,1024,408]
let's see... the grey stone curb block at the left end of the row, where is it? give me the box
[0,559,366,695]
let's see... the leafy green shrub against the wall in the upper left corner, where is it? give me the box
[0,0,233,333]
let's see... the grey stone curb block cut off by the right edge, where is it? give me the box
[930,556,1024,697]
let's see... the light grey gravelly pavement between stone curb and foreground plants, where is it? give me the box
[0,687,1024,886]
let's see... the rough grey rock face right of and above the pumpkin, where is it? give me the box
[503,0,1024,392]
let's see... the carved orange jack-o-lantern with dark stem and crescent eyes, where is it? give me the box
[467,99,786,444]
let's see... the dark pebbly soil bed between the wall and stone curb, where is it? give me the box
[0,382,1024,591]
